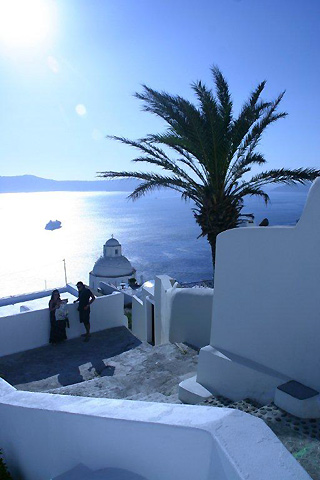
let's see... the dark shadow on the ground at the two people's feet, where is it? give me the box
[0,327,141,391]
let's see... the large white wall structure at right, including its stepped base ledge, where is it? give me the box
[179,178,320,418]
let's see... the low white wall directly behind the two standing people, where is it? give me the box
[0,292,127,357]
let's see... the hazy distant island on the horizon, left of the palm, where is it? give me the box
[0,175,139,193]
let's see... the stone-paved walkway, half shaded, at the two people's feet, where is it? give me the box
[0,327,197,403]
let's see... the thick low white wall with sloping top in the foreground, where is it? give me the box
[0,379,310,480]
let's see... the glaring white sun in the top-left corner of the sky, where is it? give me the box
[0,0,54,47]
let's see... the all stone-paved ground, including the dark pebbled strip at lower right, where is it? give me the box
[0,327,320,480]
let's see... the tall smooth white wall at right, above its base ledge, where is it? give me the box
[198,178,320,400]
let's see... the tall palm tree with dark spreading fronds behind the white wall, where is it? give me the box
[99,67,320,274]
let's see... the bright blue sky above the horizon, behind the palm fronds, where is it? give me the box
[0,0,320,180]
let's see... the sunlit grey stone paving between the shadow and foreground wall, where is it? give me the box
[48,344,198,403]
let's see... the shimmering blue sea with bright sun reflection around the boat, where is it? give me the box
[0,190,307,297]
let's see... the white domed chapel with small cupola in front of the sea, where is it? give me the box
[89,236,136,290]
